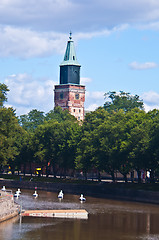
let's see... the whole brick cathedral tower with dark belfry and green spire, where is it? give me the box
[54,33,85,121]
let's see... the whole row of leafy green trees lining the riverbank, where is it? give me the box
[0,84,159,184]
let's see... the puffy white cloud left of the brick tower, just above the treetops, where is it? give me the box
[4,73,57,115]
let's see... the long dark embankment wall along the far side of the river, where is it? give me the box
[0,180,159,204]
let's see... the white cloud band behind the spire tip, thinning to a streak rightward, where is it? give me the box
[0,25,130,58]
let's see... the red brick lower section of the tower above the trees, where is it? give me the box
[54,84,85,121]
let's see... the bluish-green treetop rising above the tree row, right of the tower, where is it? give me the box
[104,91,144,112]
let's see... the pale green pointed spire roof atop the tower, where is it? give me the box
[60,32,80,66]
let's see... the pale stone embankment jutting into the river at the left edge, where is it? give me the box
[0,191,19,222]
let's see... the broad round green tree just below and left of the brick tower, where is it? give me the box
[33,120,79,177]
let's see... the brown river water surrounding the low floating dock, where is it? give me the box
[0,190,159,240]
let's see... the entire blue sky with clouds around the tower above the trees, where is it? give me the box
[0,0,159,115]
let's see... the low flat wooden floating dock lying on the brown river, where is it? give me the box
[21,209,88,219]
